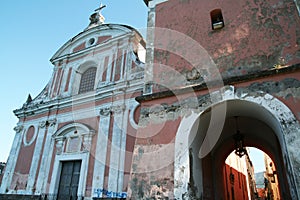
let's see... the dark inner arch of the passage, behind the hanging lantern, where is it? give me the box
[209,115,291,199]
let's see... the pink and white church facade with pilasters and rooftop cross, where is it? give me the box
[0,4,145,199]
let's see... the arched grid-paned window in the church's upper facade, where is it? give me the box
[78,67,97,94]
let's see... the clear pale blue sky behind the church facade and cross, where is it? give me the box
[0,0,262,172]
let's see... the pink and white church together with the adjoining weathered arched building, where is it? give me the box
[0,0,300,200]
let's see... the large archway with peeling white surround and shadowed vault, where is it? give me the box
[174,86,300,199]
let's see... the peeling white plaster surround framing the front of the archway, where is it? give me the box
[174,84,300,199]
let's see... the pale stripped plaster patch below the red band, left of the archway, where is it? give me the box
[128,146,174,199]
